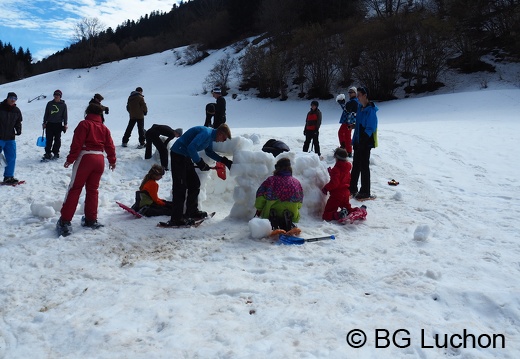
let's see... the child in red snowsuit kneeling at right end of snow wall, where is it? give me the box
[321,148,352,221]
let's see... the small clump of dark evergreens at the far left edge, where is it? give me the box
[0,41,32,83]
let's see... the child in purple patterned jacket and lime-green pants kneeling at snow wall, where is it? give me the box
[255,158,303,231]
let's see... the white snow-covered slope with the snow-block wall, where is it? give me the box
[0,45,520,358]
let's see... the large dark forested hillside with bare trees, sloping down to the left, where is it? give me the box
[1,0,520,100]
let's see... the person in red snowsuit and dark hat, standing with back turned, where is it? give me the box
[56,104,116,236]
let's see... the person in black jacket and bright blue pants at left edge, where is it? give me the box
[0,92,23,184]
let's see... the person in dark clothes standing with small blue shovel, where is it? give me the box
[42,90,68,160]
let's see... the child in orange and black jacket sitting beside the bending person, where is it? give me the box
[132,164,172,217]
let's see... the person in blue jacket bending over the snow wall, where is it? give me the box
[164,124,233,227]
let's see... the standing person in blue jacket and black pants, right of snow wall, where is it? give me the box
[350,87,379,200]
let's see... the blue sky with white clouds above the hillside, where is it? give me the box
[0,0,177,61]
